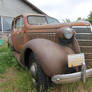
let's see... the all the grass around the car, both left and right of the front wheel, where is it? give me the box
[0,44,92,92]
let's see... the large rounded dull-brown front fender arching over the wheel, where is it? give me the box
[21,39,73,77]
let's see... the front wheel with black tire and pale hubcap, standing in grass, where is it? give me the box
[29,53,51,92]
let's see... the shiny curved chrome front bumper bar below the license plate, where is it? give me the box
[51,68,92,84]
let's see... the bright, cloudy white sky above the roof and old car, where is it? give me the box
[28,0,92,21]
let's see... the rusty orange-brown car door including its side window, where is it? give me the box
[12,16,25,52]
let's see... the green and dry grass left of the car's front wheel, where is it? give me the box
[0,44,33,92]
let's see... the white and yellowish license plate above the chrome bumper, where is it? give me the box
[68,53,85,68]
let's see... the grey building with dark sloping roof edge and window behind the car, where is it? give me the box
[0,0,45,39]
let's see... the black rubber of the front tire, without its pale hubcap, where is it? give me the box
[29,53,51,92]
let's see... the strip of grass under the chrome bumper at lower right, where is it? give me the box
[50,78,92,92]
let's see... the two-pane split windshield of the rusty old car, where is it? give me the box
[28,16,60,25]
